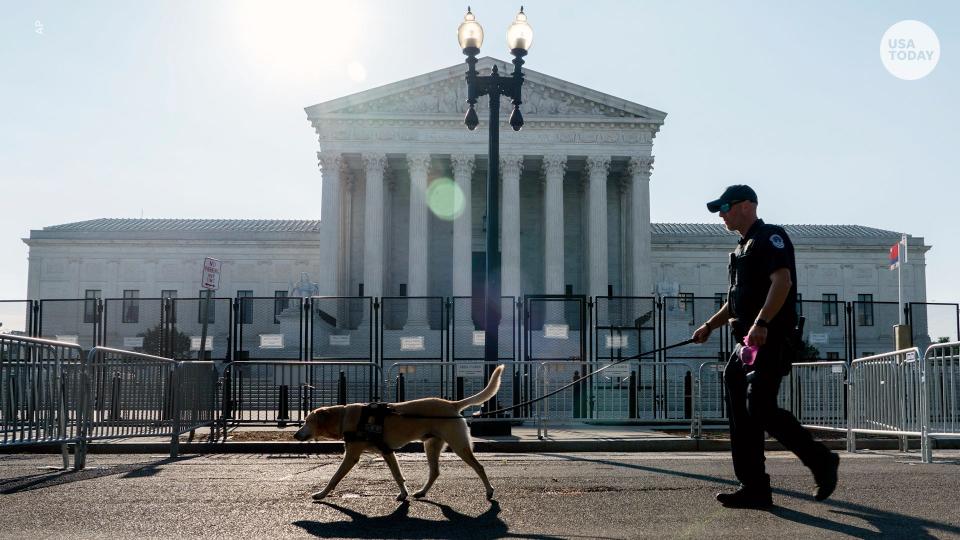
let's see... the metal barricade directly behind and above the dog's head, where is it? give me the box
[224,360,383,427]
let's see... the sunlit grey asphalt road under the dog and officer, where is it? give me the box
[0,451,960,539]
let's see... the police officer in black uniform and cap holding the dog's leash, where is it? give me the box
[693,185,840,508]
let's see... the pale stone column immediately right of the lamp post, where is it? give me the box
[500,155,523,298]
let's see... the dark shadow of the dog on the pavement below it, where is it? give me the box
[293,499,558,540]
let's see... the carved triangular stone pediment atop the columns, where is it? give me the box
[306,56,666,124]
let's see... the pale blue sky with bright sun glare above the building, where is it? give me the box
[0,0,960,326]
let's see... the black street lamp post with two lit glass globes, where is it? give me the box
[457,7,533,372]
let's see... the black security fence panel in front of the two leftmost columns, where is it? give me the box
[307,297,379,362]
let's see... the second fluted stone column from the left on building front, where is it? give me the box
[363,154,387,296]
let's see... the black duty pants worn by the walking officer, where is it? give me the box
[723,343,830,490]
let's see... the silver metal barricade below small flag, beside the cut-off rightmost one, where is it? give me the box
[847,347,925,451]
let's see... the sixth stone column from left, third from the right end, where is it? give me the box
[543,155,567,322]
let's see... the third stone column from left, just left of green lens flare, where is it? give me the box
[407,154,430,324]
